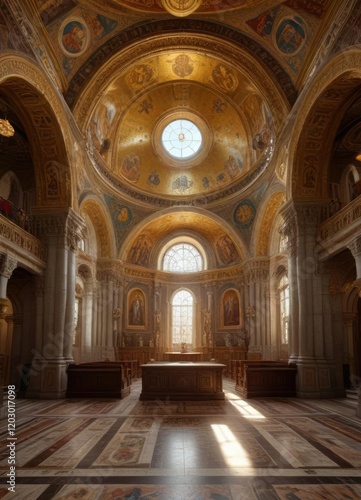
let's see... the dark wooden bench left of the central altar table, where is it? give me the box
[66,361,131,398]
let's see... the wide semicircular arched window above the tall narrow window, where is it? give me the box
[162,243,204,273]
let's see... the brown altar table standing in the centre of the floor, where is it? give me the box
[139,362,226,400]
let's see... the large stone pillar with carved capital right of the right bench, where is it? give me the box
[283,203,344,398]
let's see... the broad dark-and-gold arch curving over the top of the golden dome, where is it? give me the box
[71,19,296,122]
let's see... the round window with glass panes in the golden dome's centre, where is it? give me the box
[162,119,202,160]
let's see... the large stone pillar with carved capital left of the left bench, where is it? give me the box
[31,210,84,399]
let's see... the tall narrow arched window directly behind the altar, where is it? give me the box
[172,289,194,348]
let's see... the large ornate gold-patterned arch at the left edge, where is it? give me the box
[0,52,76,208]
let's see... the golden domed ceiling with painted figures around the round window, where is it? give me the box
[88,50,274,197]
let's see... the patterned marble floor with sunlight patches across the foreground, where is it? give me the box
[0,379,361,500]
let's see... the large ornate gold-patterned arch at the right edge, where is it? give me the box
[284,48,361,201]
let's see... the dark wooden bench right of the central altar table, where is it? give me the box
[236,360,297,398]
